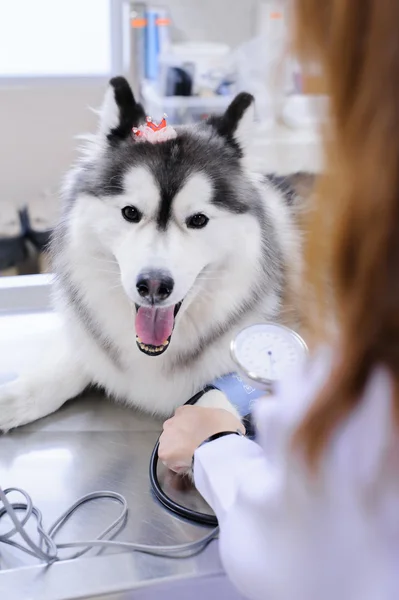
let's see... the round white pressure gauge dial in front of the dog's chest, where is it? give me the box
[231,323,308,392]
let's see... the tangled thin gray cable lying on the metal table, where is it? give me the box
[0,487,219,564]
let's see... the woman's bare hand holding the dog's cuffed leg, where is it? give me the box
[158,406,245,473]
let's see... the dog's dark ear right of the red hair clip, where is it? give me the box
[209,92,255,151]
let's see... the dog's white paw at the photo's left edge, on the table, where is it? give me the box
[0,379,43,433]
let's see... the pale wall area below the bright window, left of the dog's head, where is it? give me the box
[0,82,106,204]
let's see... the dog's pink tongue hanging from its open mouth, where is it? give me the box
[136,306,175,346]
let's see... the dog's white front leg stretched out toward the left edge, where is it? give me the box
[0,335,90,432]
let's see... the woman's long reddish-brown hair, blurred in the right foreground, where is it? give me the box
[294,0,399,465]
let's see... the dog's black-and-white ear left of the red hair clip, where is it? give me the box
[100,77,145,143]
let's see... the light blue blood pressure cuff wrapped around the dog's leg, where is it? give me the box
[212,373,265,438]
